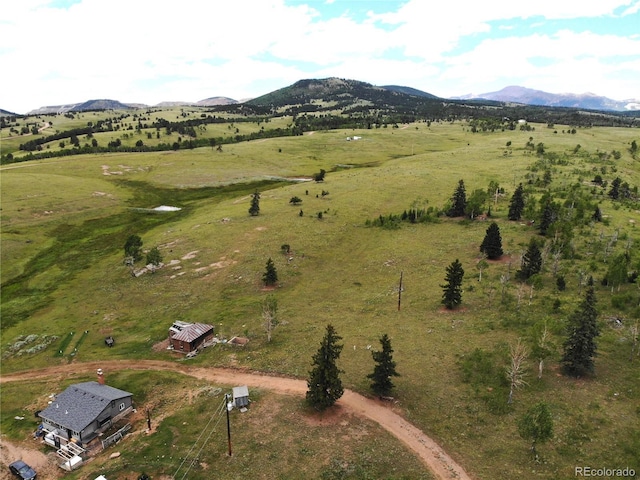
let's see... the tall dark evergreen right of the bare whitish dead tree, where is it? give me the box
[561,286,600,377]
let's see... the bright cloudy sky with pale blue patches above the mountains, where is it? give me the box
[0,0,640,113]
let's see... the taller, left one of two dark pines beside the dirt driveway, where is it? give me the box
[306,324,344,410]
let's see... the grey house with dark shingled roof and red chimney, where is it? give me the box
[38,371,133,448]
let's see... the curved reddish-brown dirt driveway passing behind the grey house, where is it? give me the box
[0,360,471,480]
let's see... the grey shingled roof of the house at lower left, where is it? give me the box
[38,382,133,432]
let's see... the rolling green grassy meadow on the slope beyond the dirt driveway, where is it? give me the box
[1,118,640,479]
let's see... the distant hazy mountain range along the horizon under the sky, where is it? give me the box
[0,78,640,115]
